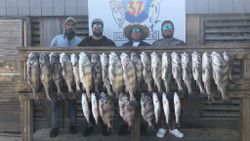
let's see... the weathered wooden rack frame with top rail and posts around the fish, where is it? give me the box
[16,45,250,141]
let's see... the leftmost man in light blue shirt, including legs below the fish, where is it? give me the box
[50,17,81,138]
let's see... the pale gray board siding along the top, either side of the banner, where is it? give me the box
[0,0,250,16]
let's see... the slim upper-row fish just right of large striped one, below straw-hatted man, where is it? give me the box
[131,52,143,91]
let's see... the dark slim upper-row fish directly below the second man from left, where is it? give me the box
[91,53,102,94]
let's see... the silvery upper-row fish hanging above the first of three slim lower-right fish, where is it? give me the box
[151,52,162,93]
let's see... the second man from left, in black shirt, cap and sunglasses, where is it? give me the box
[78,18,116,46]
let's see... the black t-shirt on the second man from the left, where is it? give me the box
[78,36,116,47]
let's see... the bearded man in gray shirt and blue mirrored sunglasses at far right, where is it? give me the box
[153,20,185,46]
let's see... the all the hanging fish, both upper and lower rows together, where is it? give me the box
[27,52,232,129]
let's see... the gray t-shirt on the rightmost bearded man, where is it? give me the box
[153,38,185,46]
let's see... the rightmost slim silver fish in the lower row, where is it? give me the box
[174,92,181,125]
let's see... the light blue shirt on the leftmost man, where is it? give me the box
[50,34,81,48]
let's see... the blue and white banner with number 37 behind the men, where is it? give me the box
[88,0,186,46]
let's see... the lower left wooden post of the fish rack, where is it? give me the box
[19,95,33,141]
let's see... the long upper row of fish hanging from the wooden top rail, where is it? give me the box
[27,51,232,102]
